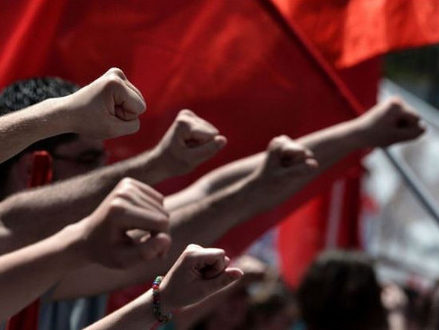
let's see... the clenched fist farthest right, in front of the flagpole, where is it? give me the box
[357,99,425,147]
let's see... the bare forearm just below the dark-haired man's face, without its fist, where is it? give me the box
[0,147,166,253]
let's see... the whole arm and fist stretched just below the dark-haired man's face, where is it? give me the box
[0,110,226,253]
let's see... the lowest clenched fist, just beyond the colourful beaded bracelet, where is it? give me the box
[160,244,243,312]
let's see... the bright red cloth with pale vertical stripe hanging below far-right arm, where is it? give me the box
[277,168,363,289]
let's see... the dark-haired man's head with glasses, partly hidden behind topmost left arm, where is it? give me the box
[0,77,104,197]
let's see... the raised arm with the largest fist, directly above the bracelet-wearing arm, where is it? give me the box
[0,179,170,320]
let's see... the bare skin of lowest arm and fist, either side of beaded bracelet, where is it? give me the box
[87,244,243,330]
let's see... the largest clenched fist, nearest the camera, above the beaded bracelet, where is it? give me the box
[77,178,171,268]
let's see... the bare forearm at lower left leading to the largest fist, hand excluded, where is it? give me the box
[0,228,81,320]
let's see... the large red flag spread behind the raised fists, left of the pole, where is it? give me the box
[0,0,434,314]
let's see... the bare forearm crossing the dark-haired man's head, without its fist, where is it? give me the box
[0,99,71,163]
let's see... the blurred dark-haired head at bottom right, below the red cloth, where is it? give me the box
[298,251,387,330]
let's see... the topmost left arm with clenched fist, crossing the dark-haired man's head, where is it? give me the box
[0,68,146,163]
